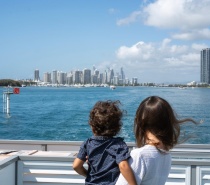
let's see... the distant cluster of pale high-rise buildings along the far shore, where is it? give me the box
[33,66,138,85]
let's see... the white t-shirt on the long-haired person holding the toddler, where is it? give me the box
[116,145,171,185]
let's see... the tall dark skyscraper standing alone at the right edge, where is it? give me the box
[200,48,210,84]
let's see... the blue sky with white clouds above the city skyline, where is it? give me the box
[0,0,210,83]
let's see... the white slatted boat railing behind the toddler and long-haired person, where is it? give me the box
[0,140,210,185]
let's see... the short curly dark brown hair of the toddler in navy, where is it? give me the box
[89,100,124,137]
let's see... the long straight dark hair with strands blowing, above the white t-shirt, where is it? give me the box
[134,96,197,150]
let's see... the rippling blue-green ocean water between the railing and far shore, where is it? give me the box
[0,87,210,144]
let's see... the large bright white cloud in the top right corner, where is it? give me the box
[117,0,210,40]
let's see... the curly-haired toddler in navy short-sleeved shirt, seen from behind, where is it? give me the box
[73,101,136,185]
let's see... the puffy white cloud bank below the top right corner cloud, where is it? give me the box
[116,39,197,66]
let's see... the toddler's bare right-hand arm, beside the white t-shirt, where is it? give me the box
[119,160,137,185]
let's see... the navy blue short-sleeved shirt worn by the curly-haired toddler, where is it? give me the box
[77,136,130,185]
